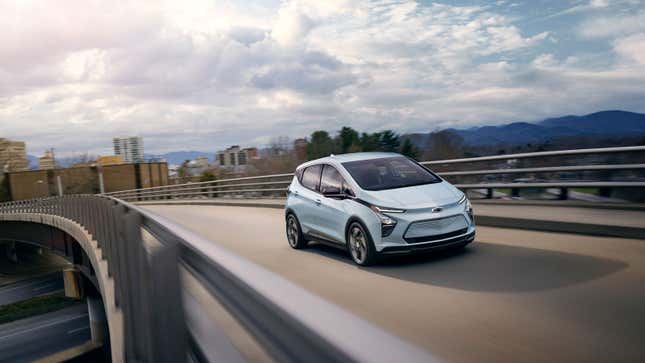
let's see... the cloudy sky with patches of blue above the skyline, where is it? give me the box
[0,0,645,155]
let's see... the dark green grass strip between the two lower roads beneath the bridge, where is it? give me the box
[0,293,80,324]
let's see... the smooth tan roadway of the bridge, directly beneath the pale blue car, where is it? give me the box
[145,206,645,362]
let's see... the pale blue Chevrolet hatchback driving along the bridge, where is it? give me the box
[285,153,475,266]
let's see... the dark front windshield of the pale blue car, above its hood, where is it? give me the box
[343,156,441,190]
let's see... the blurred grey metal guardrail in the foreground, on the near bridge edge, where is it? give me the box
[0,195,436,363]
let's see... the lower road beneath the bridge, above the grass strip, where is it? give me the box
[0,272,65,306]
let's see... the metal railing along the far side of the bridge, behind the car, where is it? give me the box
[106,146,645,201]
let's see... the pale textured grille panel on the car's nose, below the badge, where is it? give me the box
[403,214,468,243]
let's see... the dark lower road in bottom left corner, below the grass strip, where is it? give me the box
[0,304,91,363]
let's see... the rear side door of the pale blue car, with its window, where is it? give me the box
[295,164,322,233]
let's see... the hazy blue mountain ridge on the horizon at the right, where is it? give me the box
[450,111,645,146]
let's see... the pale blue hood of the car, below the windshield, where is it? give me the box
[362,181,463,209]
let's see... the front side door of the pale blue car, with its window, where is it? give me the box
[318,164,349,244]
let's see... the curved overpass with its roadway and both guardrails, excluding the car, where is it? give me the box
[0,147,645,362]
